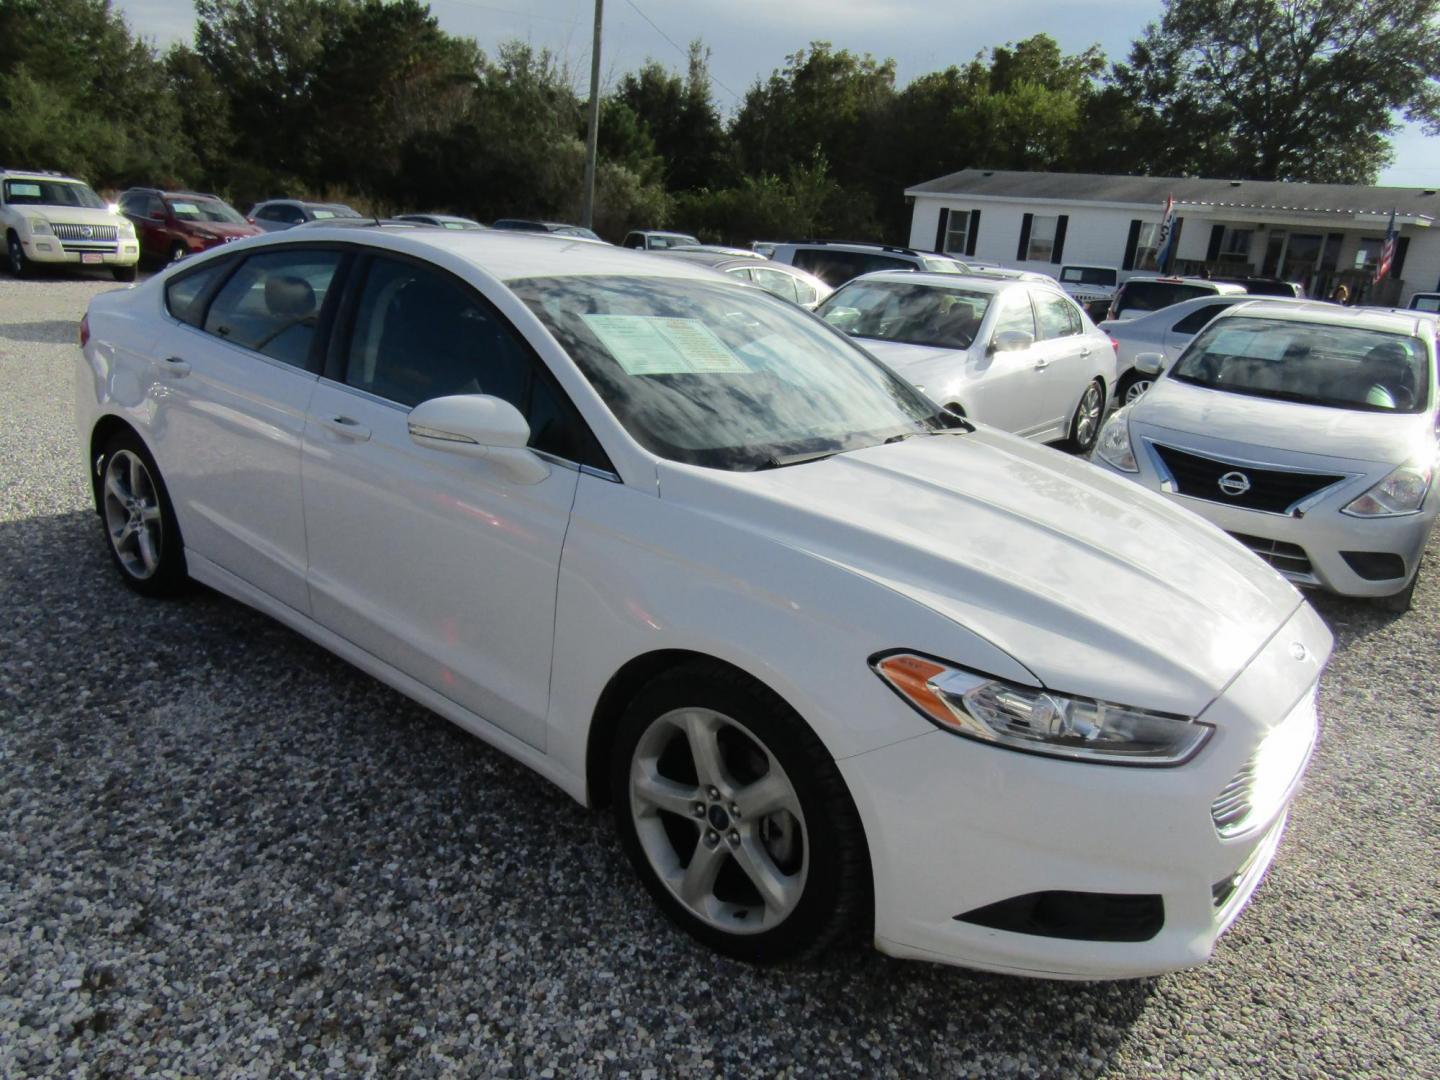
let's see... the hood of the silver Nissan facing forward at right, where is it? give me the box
[1130,379,1434,465]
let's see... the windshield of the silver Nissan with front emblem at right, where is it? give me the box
[1171,315,1430,412]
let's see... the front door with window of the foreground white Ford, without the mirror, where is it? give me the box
[304,255,588,749]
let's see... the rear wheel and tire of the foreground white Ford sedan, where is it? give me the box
[96,432,187,596]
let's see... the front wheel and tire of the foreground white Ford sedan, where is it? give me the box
[611,662,870,963]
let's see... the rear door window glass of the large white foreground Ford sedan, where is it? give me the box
[204,251,340,367]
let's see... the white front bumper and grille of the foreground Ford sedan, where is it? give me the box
[840,605,1331,979]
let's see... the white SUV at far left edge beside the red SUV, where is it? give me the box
[0,168,140,281]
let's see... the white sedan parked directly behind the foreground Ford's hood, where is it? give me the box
[815,271,1115,454]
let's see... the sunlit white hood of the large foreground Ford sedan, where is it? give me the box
[660,428,1303,716]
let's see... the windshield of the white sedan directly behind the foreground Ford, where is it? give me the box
[815,279,994,348]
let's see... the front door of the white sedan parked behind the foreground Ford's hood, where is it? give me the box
[958,288,1050,435]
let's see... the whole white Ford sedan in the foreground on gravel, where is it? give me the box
[76,228,1331,979]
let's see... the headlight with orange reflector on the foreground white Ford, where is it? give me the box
[871,652,1214,766]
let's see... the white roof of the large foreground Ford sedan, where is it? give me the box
[258,222,716,281]
